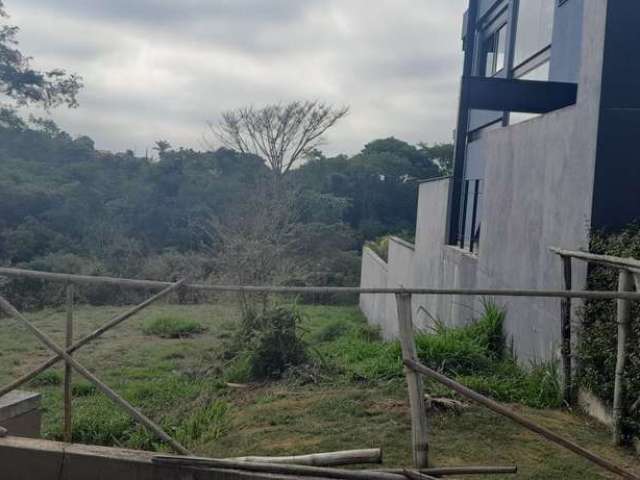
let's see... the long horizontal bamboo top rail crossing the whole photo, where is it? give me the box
[0,267,640,301]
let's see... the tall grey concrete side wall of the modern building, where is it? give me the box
[363,0,607,362]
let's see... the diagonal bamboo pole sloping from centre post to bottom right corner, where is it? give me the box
[405,361,640,480]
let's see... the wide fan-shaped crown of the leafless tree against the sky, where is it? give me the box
[210,101,349,178]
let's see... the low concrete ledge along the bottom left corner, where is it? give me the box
[0,437,320,480]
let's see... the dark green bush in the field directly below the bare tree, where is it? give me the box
[233,306,307,380]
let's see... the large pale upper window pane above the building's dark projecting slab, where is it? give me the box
[514,0,556,66]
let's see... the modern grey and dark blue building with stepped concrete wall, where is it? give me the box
[360,0,640,361]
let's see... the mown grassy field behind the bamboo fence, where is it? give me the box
[0,305,640,480]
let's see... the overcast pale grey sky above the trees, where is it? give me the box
[5,0,466,154]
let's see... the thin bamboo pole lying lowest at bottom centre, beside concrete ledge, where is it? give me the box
[151,455,407,480]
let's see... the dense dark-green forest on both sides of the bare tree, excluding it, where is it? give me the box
[0,109,450,275]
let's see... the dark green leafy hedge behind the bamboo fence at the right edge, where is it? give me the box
[579,223,640,434]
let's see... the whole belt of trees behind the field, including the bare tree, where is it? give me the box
[0,0,452,304]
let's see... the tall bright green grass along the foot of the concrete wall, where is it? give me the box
[312,301,562,408]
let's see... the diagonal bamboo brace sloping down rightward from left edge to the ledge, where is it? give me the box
[0,295,190,455]
